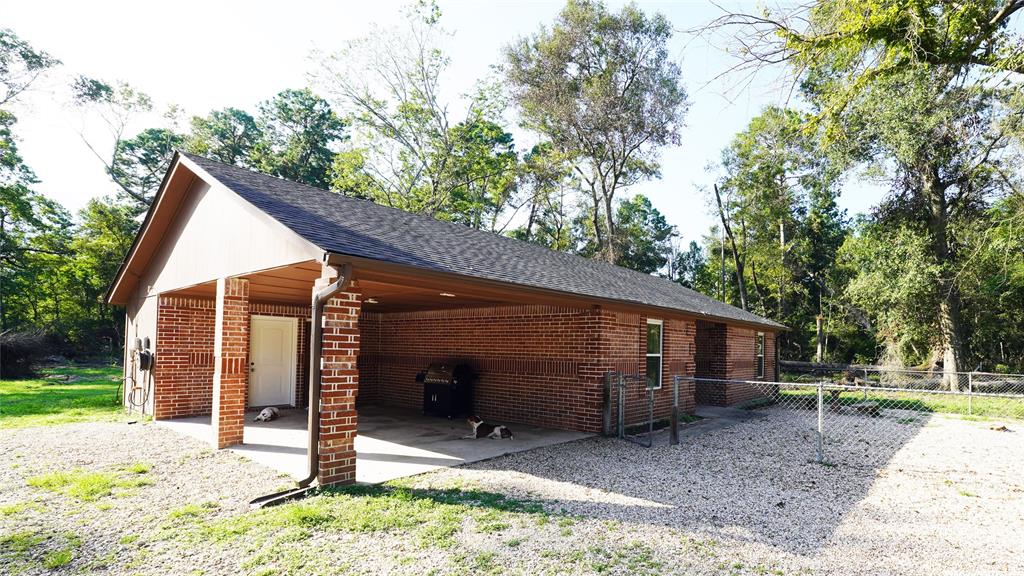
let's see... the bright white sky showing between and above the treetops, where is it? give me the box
[0,0,882,242]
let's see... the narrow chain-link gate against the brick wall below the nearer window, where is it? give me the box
[604,372,683,448]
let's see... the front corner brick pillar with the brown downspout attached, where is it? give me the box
[310,279,360,486]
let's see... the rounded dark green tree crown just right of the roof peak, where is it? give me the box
[249,88,346,189]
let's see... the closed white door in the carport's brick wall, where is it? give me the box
[249,316,297,406]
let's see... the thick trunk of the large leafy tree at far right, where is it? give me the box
[924,165,966,390]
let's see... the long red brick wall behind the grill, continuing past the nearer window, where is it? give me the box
[359,305,694,431]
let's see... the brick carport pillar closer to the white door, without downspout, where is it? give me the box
[211,278,250,448]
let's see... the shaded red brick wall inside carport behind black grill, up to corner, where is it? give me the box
[359,306,600,428]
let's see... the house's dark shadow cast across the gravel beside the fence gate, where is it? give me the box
[466,408,932,554]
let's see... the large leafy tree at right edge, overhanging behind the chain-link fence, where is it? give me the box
[718,0,1024,370]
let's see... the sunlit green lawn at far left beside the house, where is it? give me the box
[0,366,123,429]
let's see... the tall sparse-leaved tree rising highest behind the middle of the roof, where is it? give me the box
[505,0,687,262]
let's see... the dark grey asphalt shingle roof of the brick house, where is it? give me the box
[182,153,784,329]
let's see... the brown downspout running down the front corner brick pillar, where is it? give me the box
[249,252,352,507]
